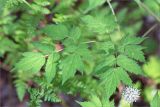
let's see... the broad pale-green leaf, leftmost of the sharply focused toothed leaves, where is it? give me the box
[15,52,45,73]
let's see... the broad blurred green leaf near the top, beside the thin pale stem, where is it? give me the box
[81,11,117,35]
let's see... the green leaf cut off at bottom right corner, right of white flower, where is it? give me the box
[150,92,160,107]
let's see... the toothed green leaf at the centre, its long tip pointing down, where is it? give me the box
[61,54,83,84]
